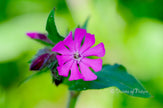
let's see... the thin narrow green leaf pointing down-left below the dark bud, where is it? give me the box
[18,68,49,86]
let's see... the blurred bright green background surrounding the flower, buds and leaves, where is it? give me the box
[0,0,163,108]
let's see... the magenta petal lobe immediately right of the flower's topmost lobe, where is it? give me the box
[80,33,95,53]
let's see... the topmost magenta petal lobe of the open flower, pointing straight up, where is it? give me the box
[74,28,87,51]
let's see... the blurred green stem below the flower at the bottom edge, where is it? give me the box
[67,91,80,108]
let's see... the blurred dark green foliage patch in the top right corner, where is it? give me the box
[118,0,163,21]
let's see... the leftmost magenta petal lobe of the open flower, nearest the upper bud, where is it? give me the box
[52,41,72,55]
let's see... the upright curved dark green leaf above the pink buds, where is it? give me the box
[46,9,64,44]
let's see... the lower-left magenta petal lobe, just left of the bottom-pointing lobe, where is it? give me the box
[57,60,73,77]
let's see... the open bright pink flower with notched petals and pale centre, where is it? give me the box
[52,28,105,81]
